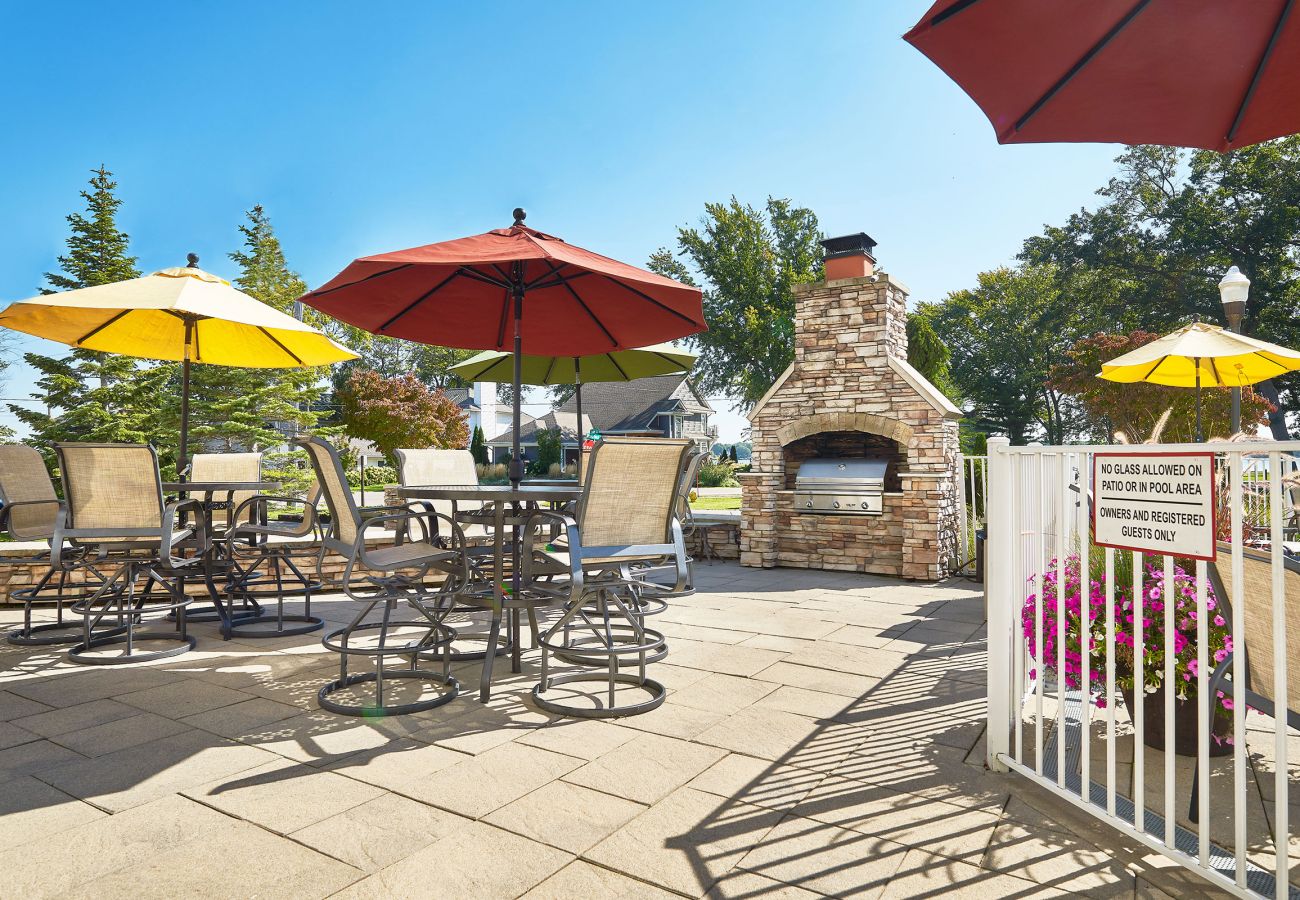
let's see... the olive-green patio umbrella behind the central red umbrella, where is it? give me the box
[449,343,696,468]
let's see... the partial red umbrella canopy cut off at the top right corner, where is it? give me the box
[905,0,1300,151]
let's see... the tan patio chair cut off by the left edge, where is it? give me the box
[0,443,104,646]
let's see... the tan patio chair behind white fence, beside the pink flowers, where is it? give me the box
[1188,544,1300,822]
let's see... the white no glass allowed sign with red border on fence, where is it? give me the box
[1092,453,1214,559]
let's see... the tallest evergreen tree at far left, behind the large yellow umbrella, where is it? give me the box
[9,165,161,462]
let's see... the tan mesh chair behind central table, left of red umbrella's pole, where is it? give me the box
[397,447,517,662]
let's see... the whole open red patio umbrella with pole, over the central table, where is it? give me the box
[302,209,706,484]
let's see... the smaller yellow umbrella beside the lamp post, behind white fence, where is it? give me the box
[1097,323,1300,440]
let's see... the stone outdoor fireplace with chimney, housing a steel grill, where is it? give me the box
[740,234,962,580]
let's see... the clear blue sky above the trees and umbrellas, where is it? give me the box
[0,0,1117,440]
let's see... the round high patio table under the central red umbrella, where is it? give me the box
[397,481,582,702]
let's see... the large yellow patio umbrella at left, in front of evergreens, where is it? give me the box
[0,254,356,470]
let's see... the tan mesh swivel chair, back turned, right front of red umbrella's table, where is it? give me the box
[524,438,692,718]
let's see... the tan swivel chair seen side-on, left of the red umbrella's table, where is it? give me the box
[295,437,469,715]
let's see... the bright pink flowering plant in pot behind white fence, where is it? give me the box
[1021,553,1232,710]
